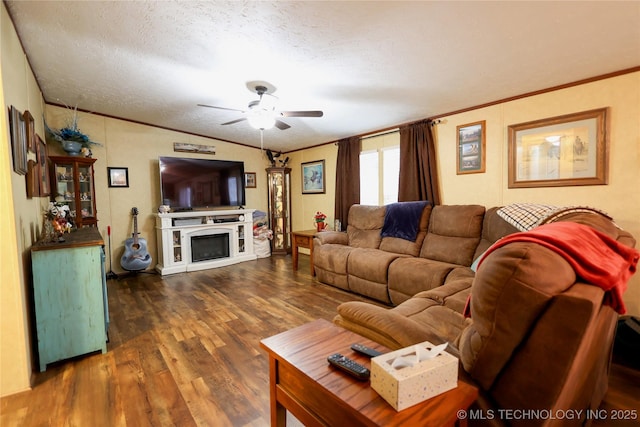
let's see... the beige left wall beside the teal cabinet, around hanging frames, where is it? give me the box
[0,3,47,395]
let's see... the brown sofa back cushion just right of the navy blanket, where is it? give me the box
[420,205,485,267]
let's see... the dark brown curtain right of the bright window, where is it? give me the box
[398,121,440,206]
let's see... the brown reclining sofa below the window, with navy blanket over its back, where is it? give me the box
[313,205,508,305]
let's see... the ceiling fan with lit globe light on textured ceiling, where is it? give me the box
[198,81,324,130]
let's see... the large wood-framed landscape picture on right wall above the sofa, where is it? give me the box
[508,108,609,188]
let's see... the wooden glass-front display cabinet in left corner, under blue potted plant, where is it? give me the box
[49,156,98,228]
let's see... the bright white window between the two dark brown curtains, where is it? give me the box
[360,146,400,205]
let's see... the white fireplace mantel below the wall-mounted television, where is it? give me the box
[156,209,257,276]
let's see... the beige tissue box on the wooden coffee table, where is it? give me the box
[371,341,458,411]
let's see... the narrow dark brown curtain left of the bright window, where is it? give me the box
[334,136,360,230]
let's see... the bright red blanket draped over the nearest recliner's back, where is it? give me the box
[478,222,640,314]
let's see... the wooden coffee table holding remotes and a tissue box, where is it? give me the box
[260,319,478,427]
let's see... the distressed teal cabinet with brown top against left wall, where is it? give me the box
[31,227,109,372]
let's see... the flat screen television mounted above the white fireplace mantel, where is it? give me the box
[159,157,245,211]
